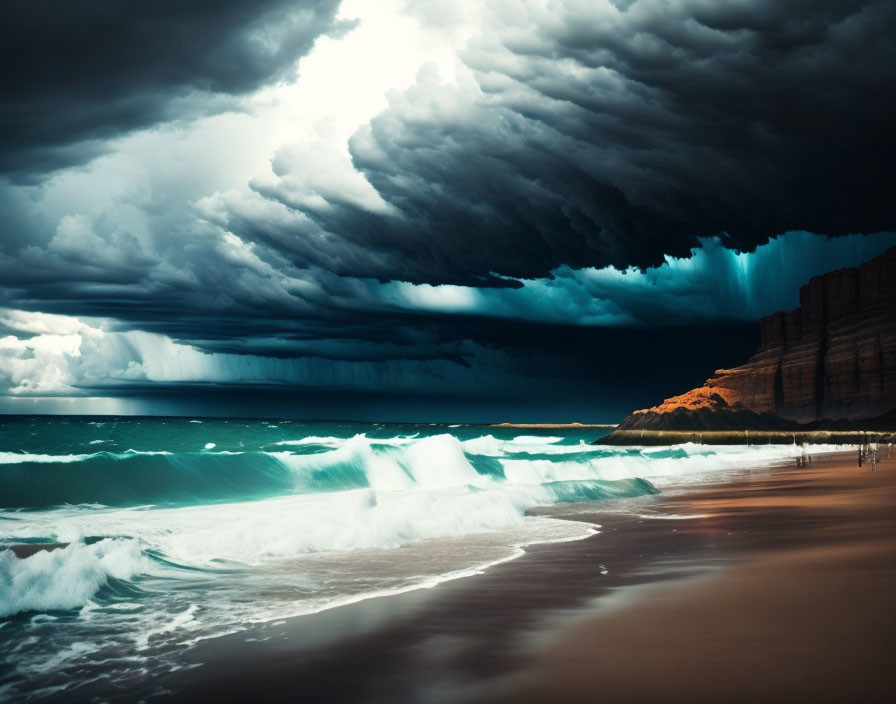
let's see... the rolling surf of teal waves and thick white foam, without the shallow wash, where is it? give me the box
[0,434,824,614]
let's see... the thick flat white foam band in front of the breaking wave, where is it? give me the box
[5,485,552,566]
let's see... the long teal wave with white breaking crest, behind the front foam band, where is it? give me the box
[0,434,812,509]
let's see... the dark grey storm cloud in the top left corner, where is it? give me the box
[0,0,339,180]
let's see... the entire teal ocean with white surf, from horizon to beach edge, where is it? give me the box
[0,416,801,699]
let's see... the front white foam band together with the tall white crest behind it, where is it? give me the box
[0,435,554,564]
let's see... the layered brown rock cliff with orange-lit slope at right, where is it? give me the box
[619,247,896,431]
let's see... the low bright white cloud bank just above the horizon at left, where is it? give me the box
[0,309,494,396]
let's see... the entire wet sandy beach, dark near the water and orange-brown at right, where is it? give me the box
[154,453,896,702]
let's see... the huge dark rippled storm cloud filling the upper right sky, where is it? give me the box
[233,0,896,286]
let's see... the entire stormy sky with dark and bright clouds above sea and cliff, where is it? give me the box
[0,0,896,422]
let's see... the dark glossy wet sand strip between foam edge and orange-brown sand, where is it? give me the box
[148,496,706,703]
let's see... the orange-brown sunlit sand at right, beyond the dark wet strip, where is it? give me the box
[498,453,896,702]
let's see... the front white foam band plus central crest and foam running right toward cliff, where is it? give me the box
[0,442,830,564]
